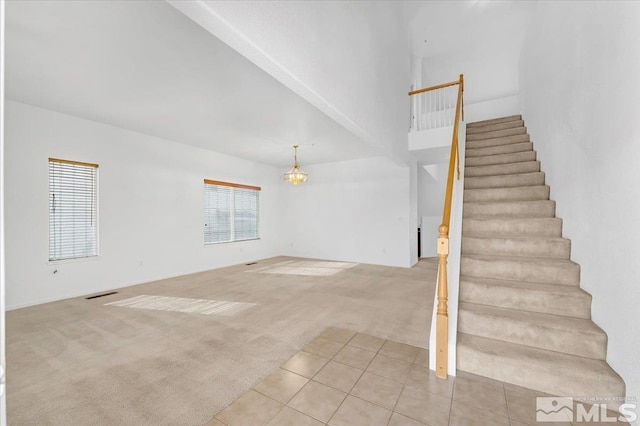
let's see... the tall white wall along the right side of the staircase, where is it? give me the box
[520,1,640,410]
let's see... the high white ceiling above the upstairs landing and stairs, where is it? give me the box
[402,0,535,58]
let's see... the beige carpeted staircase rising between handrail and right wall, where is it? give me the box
[457,115,625,407]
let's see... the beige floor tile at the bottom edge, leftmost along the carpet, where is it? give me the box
[216,390,283,426]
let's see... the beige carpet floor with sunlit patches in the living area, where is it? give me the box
[7,257,436,426]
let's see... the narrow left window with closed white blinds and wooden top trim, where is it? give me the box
[49,158,98,260]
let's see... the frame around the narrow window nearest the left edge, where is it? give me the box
[47,158,100,264]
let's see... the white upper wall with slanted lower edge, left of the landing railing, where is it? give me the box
[169,0,411,161]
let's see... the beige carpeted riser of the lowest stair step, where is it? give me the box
[457,336,625,402]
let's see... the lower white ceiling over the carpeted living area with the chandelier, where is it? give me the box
[5,1,377,167]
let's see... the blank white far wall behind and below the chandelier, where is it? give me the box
[280,157,410,267]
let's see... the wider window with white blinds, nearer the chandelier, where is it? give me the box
[204,179,260,244]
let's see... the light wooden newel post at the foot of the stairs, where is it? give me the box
[436,225,449,379]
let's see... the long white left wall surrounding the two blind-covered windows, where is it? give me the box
[5,101,283,308]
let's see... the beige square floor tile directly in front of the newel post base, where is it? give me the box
[395,386,451,426]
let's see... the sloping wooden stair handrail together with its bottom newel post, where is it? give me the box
[428,74,464,379]
